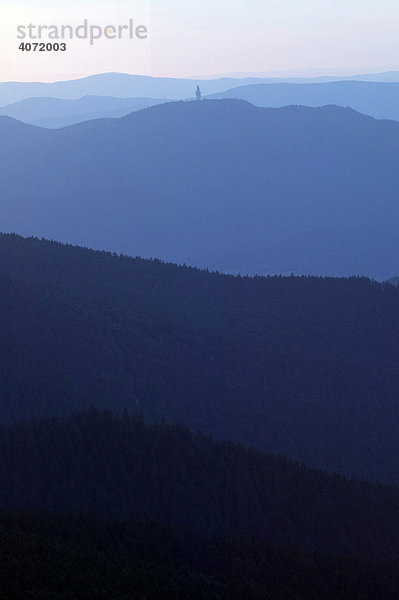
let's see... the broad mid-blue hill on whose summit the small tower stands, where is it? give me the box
[0,100,399,279]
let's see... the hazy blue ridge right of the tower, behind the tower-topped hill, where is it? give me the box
[211,81,399,120]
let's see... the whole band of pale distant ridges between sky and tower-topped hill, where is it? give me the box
[0,73,399,128]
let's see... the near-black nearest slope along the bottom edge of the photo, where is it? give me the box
[0,512,399,600]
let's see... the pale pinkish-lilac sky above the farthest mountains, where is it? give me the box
[0,0,399,81]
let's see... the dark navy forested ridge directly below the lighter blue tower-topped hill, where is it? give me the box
[0,235,399,483]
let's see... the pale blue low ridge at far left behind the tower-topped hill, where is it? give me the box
[1,96,165,128]
